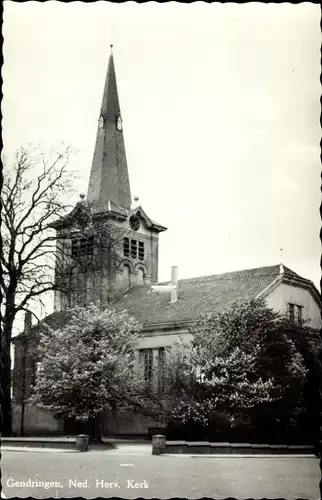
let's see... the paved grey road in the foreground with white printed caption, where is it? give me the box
[1,445,320,500]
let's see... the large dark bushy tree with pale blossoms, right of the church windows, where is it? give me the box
[145,300,307,442]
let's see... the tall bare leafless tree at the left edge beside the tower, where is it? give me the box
[0,147,72,435]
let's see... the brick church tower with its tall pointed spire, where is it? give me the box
[53,46,166,311]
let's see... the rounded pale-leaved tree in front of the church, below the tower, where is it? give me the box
[31,305,140,441]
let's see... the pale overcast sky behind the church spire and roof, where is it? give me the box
[2,1,321,308]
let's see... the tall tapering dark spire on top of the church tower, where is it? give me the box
[87,45,131,211]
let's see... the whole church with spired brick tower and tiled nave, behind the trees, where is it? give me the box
[13,47,321,436]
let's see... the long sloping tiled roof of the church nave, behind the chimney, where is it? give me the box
[111,265,292,325]
